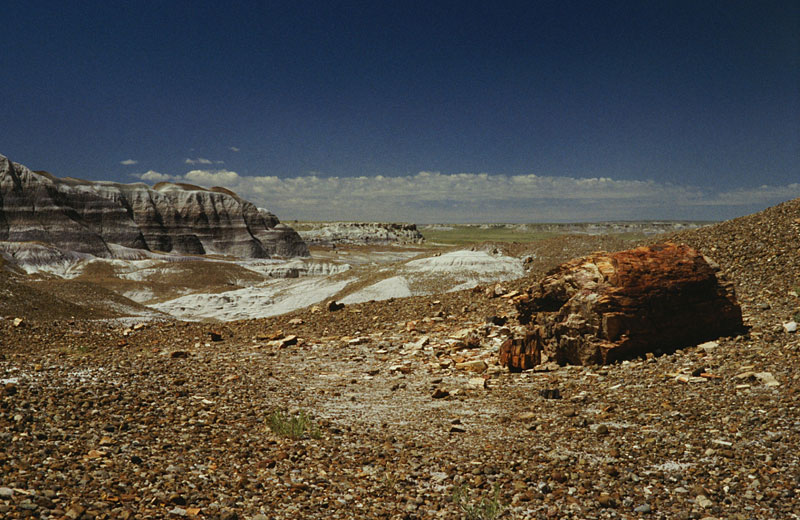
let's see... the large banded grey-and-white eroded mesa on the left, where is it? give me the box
[0,155,309,258]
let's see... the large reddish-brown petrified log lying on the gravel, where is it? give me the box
[500,243,743,370]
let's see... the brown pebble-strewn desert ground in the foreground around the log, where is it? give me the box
[0,201,800,520]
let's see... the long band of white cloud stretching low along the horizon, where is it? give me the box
[125,169,800,223]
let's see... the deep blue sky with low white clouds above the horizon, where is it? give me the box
[0,0,800,222]
